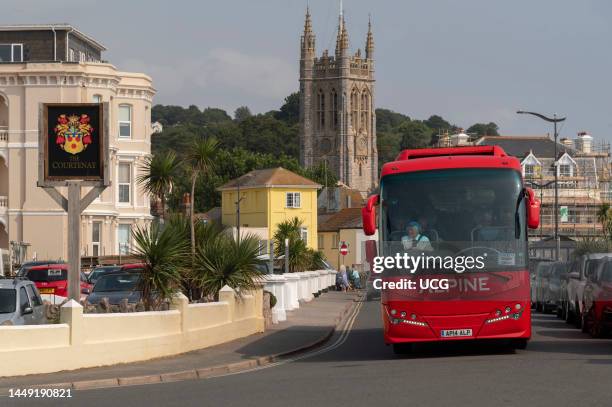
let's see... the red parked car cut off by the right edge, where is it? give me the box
[581,257,612,338]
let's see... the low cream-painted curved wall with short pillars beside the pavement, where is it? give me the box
[0,286,264,376]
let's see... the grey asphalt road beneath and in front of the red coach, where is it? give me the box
[0,294,612,407]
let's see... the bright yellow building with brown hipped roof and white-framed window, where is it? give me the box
[218,167,321,250]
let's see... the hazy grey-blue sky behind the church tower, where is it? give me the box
[0,0,612,140]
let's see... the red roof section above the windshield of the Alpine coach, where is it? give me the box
[380,146,521,177]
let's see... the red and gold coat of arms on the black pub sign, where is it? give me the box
[54,114,94,155]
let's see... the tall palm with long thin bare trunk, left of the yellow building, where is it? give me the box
[187,137,219,258]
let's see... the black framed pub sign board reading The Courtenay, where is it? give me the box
[39,103,108,186]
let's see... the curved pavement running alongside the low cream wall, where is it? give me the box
[0,291,364,394]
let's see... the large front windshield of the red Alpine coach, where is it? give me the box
[380,168,527,272]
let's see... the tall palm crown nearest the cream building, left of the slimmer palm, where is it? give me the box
[137,151,180,220]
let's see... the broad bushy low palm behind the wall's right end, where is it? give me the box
[193,233,262,300]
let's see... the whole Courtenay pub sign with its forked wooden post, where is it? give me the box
[38,103,110,301]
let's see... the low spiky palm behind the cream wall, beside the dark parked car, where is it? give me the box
[133,223,189,311]
